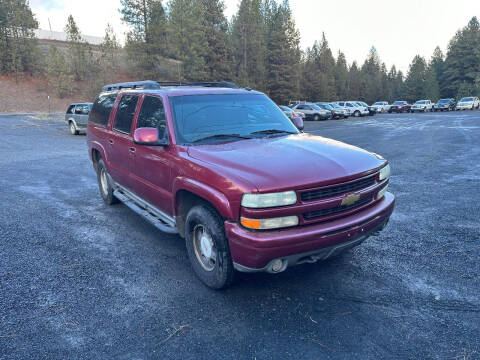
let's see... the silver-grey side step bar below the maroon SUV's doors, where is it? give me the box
[113,184,178,234]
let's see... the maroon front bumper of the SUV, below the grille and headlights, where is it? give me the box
[225,192,395,272]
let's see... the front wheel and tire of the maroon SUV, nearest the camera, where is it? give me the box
[185,205,235,289]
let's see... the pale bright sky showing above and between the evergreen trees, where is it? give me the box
[30,0,480,72]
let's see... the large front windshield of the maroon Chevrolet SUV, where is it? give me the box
[170,94,298,144]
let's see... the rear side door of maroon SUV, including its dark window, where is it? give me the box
[107,94,139,188]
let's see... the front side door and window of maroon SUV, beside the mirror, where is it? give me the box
[131,95,173,215]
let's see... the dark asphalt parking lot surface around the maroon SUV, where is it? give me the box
[0,111,480,360]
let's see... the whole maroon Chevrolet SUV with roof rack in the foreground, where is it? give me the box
[87,81,394,289]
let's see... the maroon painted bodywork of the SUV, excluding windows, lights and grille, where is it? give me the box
[87,88,394,268]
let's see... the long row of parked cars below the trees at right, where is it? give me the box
[280,96,480,121]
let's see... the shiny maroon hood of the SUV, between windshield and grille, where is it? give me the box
[188,134,386,192]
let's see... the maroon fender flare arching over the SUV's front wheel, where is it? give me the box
[172,176,238,221]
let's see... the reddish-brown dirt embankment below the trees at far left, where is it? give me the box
[0,76,92,114]
